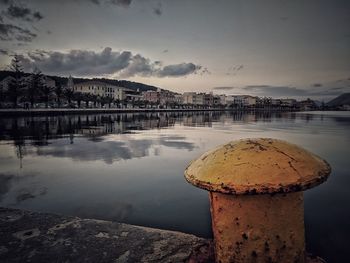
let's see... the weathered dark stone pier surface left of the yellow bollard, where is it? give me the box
[0,208,214,263]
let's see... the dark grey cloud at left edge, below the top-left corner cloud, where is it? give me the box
[0,23,37,42]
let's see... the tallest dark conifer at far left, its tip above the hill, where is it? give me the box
[7,55,24,108]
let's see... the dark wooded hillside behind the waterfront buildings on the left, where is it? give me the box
[0,70,157,91]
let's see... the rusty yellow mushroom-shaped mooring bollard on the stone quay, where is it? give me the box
[185,139,331,263]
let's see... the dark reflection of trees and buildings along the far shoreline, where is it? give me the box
[0,112,300,146]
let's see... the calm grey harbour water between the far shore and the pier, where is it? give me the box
[0,112,350,262]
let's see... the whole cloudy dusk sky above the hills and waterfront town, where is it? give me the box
[0,0,350,100]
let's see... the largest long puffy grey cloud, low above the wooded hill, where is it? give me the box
[21,47,208,77]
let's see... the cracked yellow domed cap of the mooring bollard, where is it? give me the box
[185,138,331,194]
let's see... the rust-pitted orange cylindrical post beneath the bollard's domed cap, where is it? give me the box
[210,192,306,263]
